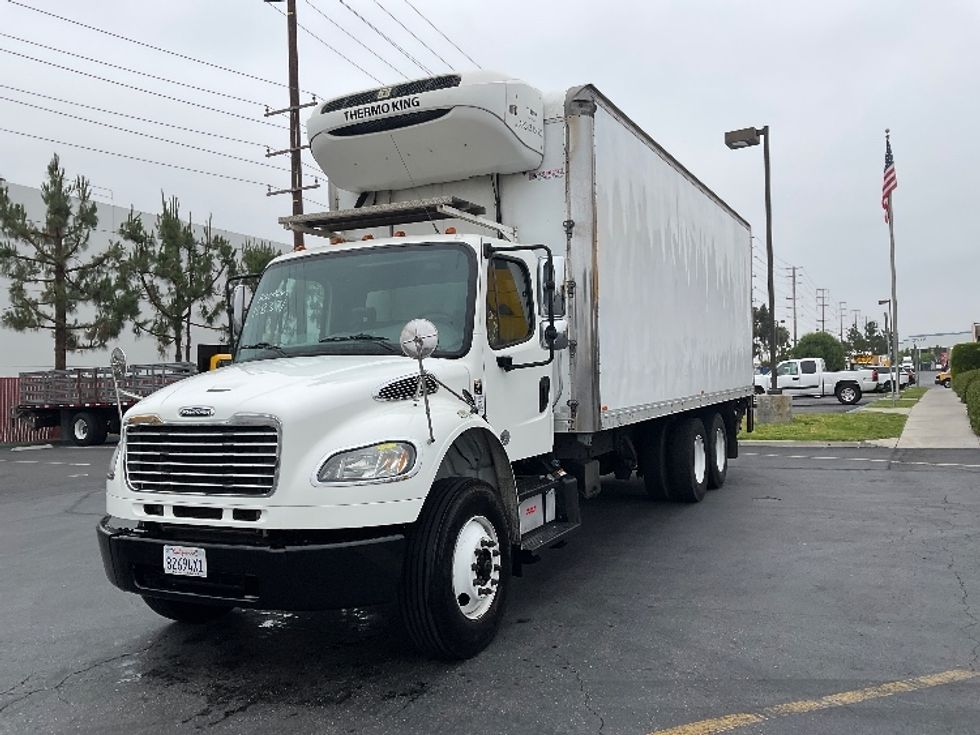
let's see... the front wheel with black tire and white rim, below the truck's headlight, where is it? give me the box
[399,478,511,660]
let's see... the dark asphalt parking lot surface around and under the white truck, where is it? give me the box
[0,440,980,735]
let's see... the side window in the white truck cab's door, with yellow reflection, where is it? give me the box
[487,257,534,349]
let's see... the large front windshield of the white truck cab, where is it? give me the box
[241,243,476,362]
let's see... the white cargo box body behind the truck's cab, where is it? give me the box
[311,80,753,433]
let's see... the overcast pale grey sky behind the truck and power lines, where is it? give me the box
[0,0,980,342]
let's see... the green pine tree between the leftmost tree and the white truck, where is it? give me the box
[119,197,237,361]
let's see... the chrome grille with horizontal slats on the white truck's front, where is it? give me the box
[126,424,279,495]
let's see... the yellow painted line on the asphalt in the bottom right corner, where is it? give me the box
[650,669,980,735]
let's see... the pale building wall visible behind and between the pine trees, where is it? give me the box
[0,182,289,377]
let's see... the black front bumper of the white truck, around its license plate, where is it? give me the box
[98,516,405,610]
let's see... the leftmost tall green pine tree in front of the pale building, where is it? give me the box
[0,154,138,370]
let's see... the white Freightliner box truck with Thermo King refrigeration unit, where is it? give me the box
[98,72,753,659]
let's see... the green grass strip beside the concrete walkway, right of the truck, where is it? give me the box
[739,411,908,441]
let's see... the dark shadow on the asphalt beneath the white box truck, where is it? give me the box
[130,480,708,726]
